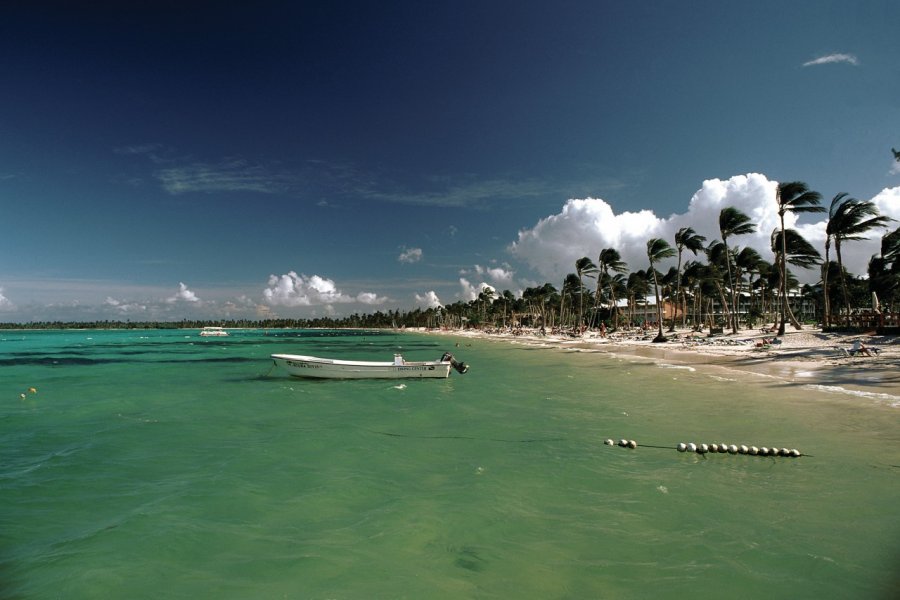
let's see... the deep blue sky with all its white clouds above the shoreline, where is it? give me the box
[0,0,900,322]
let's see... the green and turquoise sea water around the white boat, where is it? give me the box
[0,330,900,600]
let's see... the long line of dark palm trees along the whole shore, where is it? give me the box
[0,181,900,341]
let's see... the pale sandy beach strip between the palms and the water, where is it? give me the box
[429,328,900,406]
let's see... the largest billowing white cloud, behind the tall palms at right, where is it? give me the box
[509,173,900,282]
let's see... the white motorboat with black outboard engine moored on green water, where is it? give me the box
[272,352,469,379]
